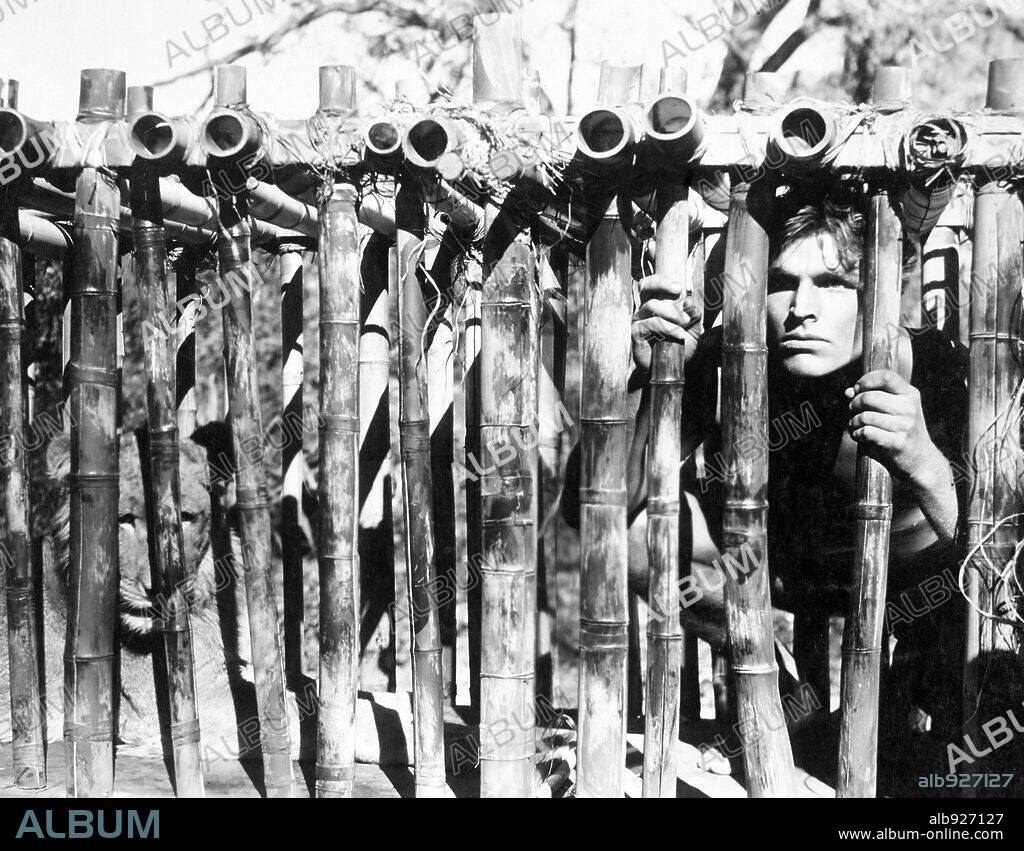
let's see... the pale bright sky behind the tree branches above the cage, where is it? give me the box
[0,0,806,120]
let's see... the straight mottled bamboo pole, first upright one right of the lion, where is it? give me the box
[316,183,360,798]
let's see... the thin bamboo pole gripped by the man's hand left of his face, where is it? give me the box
[643,181,689,798]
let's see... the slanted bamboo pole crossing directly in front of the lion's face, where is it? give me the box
[131,166,204,798]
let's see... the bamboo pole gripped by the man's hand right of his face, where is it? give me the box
[836,186,902,798]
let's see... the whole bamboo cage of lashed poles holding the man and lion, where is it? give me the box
[0,15,1024,798]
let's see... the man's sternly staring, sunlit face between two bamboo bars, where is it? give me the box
[768,233,861,378]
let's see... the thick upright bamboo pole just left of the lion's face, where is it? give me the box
[65,69,125,798]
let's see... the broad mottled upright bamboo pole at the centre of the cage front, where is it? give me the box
[479,207,540,798]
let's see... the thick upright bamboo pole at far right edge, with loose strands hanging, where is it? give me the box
[964,59,1024,753]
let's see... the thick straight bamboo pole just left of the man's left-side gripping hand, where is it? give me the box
[577,201,633,798]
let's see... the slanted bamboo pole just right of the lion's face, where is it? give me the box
[208,66,292,798]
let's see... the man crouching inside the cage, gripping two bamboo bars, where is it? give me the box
[565,187,967,790]
